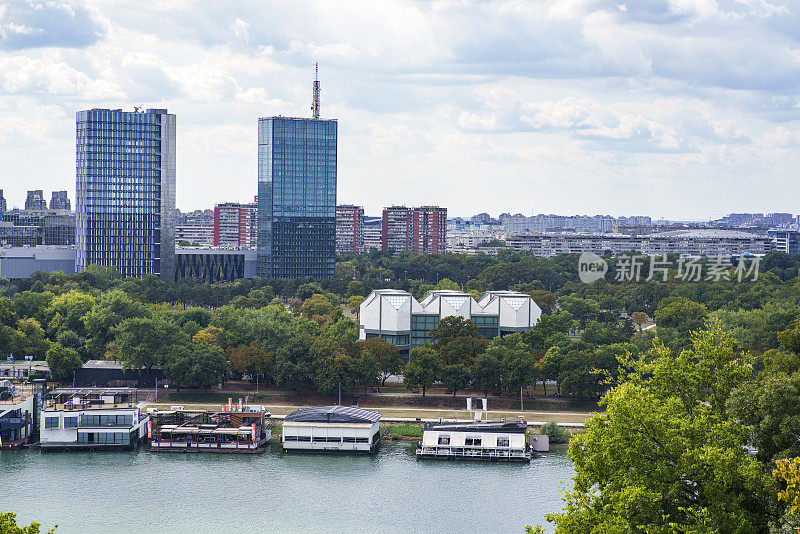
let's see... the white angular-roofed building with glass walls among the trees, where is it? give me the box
[359,289,542,353]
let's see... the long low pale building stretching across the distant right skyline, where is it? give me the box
[506,230,772,257]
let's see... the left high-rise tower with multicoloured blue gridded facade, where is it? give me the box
[75,109,176,279]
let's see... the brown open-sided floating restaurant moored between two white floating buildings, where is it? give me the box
[148,406,272,454]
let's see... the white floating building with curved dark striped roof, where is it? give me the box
[281,406,381,452]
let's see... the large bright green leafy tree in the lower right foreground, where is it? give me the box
[548,327,777,534]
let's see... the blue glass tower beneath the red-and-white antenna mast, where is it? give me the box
[257,117,337,278]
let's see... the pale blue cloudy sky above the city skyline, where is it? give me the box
[0,0,800,220]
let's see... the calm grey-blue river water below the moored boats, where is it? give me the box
[0,442,573,534]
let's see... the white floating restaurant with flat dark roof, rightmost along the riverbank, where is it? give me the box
[417,421,531,462]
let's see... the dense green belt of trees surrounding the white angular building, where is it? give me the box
[0,251,800,398]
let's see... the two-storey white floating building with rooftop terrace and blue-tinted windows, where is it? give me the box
[40,388,150,450]
